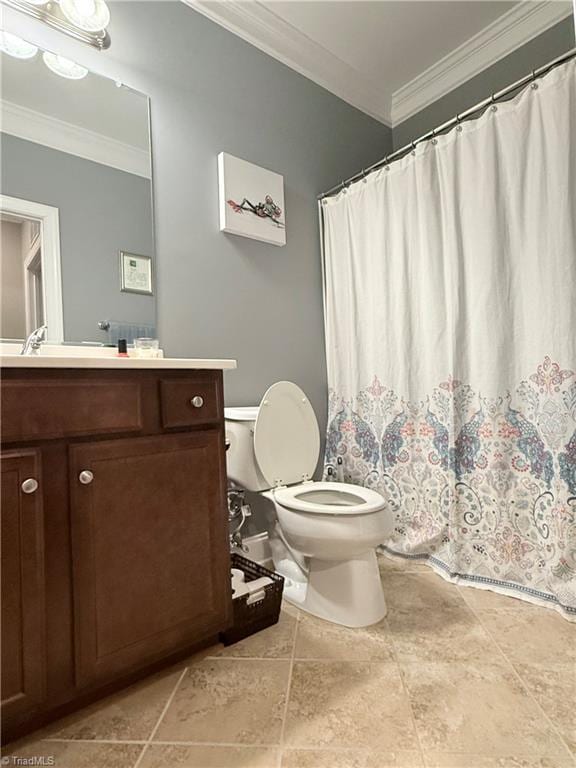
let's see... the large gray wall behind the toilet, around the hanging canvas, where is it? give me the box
[6,2,391,438]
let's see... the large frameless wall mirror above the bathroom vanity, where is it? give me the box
[0,37,156,344]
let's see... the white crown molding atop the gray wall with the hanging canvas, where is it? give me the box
[183,0,391,127]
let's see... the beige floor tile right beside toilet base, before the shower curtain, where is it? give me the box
[382,569,469,614]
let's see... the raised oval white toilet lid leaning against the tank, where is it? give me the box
[254,381,320,487]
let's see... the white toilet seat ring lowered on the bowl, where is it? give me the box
[273,482,384,516]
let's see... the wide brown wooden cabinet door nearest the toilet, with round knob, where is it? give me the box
[70,430,230,685]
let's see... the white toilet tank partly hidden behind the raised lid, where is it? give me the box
[224,406,270,491]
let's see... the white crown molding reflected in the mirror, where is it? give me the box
[0,100,152,179]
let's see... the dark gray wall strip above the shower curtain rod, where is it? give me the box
[394,17,574,149]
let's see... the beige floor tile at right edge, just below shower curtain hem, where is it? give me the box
[476,606,576,665]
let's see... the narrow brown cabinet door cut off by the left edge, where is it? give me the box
[1,450,46,719]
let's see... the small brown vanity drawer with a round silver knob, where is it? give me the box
[160,378,222,429]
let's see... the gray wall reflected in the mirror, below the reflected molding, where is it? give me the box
[0,134,156,342]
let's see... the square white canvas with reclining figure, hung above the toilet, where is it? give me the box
[218,152,286,250]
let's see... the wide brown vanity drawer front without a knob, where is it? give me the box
[2,379,142,442]
